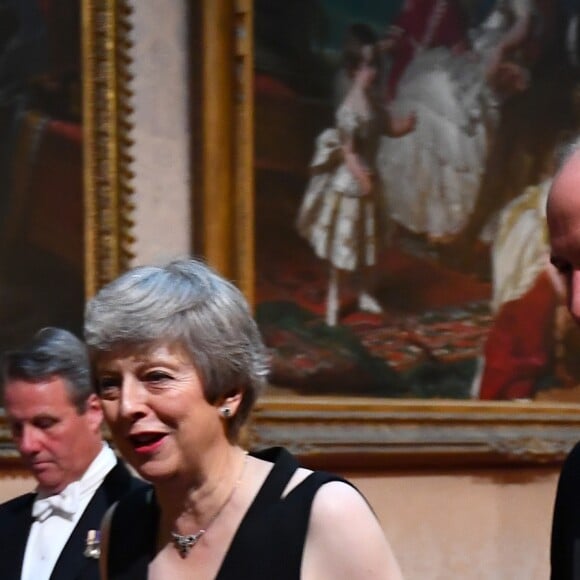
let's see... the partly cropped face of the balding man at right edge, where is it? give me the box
[547,153,580,324]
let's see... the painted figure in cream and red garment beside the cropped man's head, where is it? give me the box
[472,146,566,400]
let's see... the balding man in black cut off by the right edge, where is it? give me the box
[547,140,580,580]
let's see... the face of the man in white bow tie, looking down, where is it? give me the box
[4,376,102,494]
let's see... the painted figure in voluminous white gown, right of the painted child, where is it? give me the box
[378,0,532,242]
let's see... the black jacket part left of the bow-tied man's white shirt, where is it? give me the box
[0,493,35,578]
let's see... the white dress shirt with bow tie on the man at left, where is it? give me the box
[21,443,117,580]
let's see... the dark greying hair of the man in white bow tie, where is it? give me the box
[1,326,93,414]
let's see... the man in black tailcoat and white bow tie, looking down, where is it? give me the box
[0,328,143,580]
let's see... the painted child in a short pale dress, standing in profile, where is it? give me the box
[296,24,415,326]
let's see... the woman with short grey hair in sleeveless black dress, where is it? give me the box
[85,259,401,580]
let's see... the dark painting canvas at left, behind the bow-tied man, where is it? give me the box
[0,0,84,350]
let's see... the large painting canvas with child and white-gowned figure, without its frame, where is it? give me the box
[254,0,580,402]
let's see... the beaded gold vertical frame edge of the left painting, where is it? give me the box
[82,0,133,297]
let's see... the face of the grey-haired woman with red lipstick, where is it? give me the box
[96,344,228,483]
